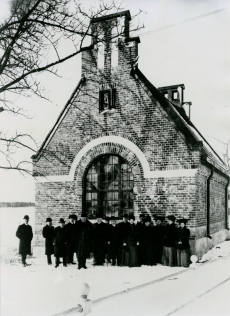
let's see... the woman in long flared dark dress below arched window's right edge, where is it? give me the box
[121,215,139,267]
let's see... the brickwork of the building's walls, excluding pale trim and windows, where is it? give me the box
[34,14,226,245]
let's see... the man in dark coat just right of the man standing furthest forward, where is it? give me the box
[93,213,107,266]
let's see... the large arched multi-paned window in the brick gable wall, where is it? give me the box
[83,154,134,218]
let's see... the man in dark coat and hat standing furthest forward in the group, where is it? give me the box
[76,212,92,270]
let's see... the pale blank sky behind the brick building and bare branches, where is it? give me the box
[0,0,230,202]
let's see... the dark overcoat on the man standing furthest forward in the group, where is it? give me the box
[76,220,93,258]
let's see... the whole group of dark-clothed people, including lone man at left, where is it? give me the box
[16,212,190,269]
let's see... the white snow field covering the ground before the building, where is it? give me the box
[0,206,230,316]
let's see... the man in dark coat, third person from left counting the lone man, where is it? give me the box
[53,218,67,268]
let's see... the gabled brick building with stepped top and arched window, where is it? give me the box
[32,11,229,256]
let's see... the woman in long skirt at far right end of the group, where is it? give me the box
[177,218,191,268]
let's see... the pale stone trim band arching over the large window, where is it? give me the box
[36,135,197,182]
